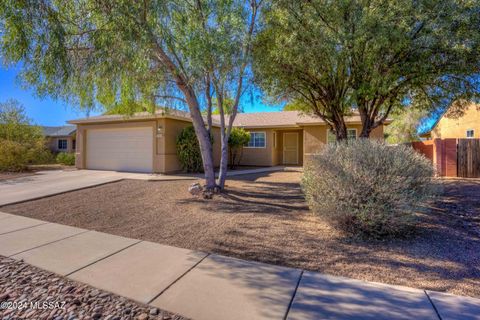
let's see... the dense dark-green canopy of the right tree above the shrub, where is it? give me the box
[254,0,480,134]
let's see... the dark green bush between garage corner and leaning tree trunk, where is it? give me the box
[176,126,203,172]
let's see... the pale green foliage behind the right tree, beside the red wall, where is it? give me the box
[385,107,428,144]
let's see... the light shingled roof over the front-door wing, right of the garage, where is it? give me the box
[214,111,391,128]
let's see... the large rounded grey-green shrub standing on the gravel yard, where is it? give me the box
[302,139,434,238]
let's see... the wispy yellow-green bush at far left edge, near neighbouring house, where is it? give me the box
[0,100,52,171]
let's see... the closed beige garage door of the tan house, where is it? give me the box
[86,127,153,172]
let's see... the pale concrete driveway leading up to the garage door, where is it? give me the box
[0,170,130,206]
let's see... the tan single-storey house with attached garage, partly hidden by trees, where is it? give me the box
[69,110,390,173]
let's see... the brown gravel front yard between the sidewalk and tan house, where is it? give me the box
[0,172,480,297]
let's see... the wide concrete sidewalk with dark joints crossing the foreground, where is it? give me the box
[0,213,480,320]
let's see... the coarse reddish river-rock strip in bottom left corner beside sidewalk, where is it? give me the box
[0,256,185,320]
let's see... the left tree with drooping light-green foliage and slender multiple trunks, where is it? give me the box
[0,0,260,190]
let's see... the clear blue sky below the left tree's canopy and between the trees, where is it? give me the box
[0,66,281,126]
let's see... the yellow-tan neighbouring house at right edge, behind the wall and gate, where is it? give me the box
[420,103,480,139]
